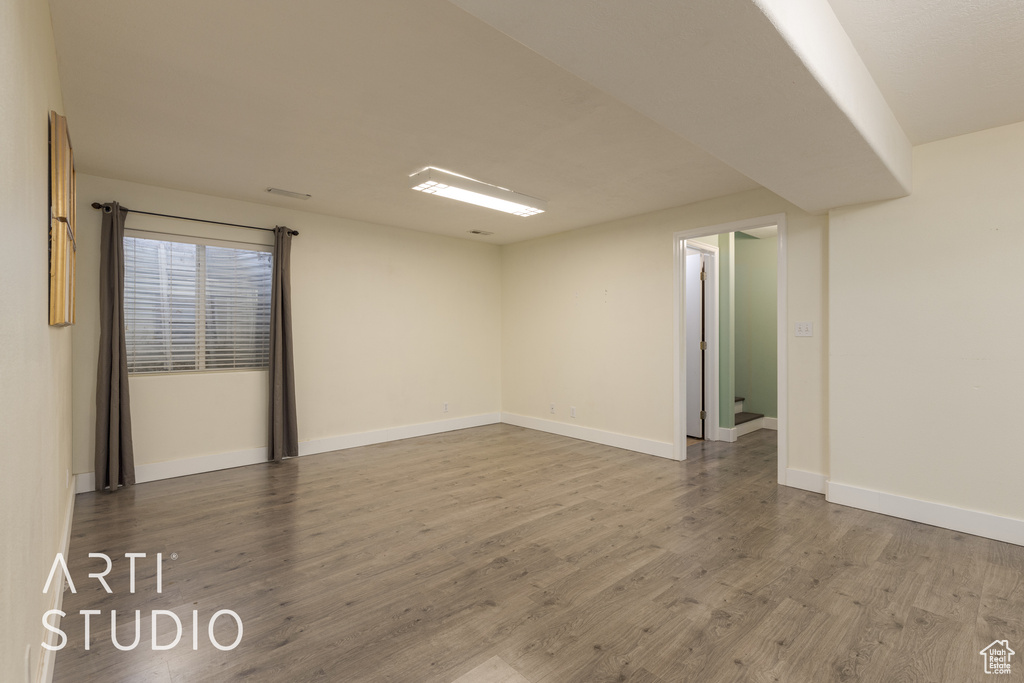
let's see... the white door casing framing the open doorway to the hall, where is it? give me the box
[672,213,790,485]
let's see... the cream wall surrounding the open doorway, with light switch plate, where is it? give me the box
[502,189,827,475]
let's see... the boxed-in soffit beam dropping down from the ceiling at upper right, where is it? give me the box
[453,0,910,212]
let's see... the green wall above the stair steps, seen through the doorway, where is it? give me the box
[737,232,778,417]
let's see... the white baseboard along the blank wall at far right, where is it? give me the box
[825,481,1024,546]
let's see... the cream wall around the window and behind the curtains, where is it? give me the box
[75,176,501,472]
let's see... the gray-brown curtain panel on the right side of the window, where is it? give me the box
[268,226,299,462]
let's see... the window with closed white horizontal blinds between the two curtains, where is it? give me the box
[124,231,272,374]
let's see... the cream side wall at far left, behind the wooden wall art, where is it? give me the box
[0,0,75,681]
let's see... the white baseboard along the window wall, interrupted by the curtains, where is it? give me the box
[76,413,501,494]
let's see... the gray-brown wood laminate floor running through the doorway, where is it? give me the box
[54,425,1024,683]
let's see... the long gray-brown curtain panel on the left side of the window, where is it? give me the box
[95,202,135,493]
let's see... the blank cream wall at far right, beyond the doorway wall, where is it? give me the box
[829,124,1024,519]
